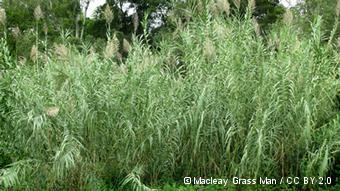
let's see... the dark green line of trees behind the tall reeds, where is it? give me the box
[1,0,339,60]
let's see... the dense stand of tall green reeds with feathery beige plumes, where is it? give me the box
[0,1,340,190]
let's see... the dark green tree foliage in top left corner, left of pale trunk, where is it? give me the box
[2,0,81,57]
